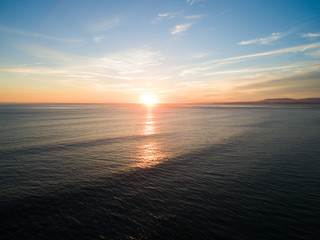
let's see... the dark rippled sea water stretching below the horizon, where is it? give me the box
[0,104,320,239]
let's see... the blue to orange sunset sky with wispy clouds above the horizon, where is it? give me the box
[0,0,320,103]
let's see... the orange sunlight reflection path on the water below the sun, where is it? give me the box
[135,107,167,168]
